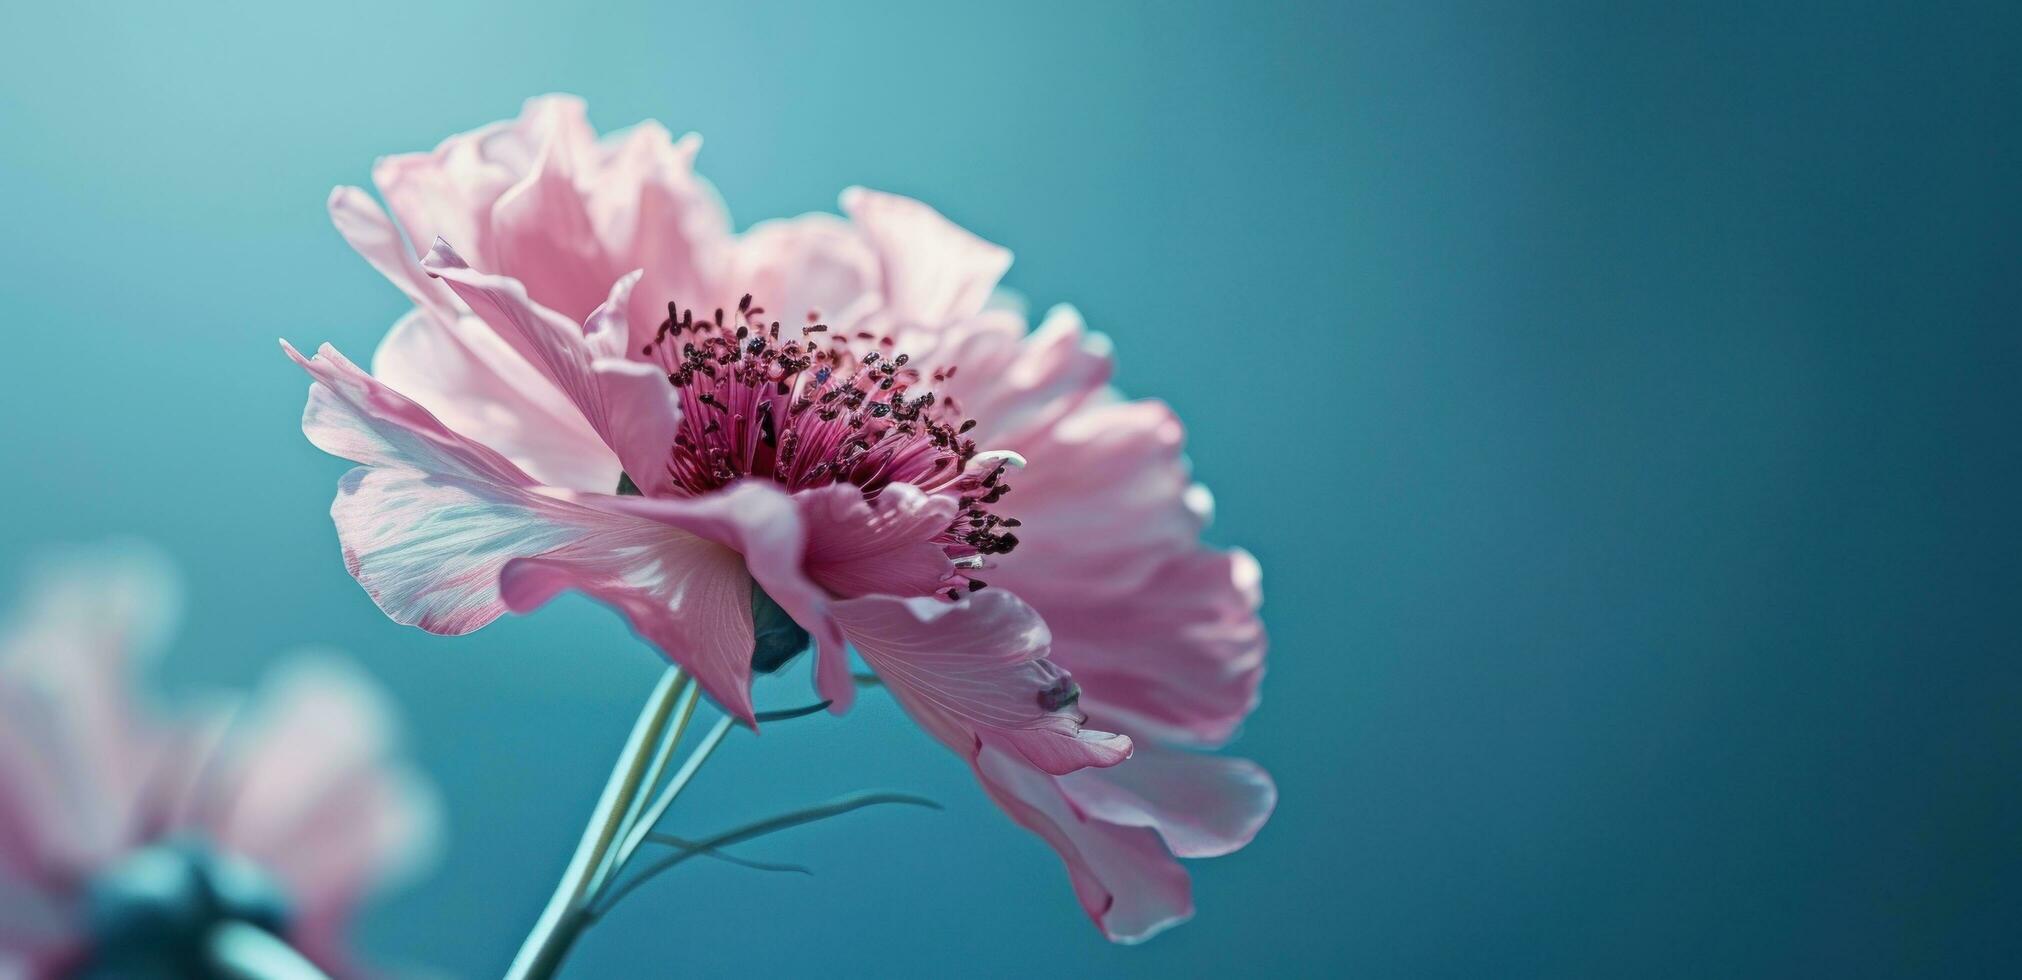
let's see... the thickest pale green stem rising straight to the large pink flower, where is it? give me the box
[506,667,694,980]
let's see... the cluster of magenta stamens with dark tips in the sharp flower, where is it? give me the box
[641,295,1019,590]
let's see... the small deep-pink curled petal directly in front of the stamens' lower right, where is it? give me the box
[795,483,956,598]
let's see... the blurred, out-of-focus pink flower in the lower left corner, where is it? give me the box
[0,554,435,978]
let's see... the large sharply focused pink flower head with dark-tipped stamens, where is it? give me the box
[289,97,1276,940]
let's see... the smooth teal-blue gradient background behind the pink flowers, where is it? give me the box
[0,2,2022,976]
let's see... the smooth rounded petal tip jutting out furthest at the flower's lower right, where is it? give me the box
[1060,746,1278,857]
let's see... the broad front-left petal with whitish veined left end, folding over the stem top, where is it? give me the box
[287,348,812,721]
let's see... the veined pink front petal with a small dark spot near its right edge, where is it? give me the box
[833,590,1130,774]
